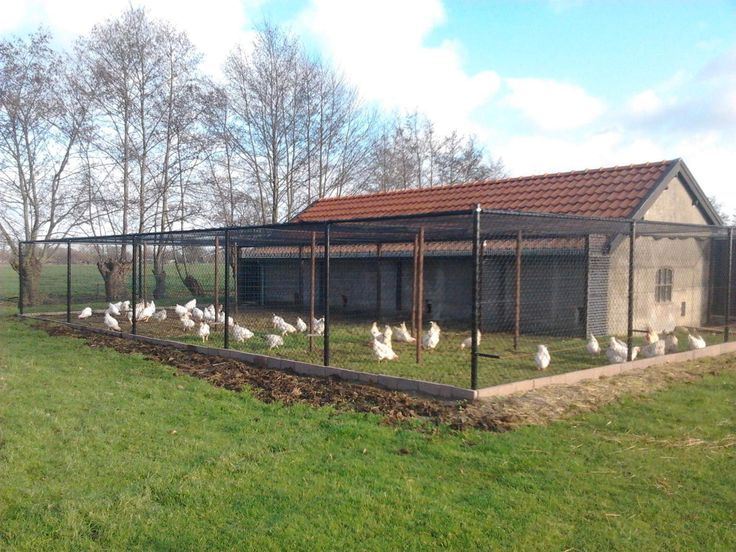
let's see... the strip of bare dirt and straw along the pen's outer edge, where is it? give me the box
[35,321,736,431]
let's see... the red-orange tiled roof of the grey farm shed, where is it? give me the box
[296,160,677,222]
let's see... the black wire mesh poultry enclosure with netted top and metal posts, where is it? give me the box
[19,210,736,387]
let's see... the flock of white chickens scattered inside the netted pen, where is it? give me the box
[78,299,706,370]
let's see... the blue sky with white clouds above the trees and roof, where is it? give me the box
[5,0,736,212]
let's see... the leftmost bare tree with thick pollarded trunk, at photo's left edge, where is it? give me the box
[0,31,87,305]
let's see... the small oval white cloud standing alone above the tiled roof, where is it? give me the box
[504,78,605,130]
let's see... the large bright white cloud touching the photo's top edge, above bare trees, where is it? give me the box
[298,0,500,136]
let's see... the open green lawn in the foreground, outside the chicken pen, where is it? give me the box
[0,312,736,551]
